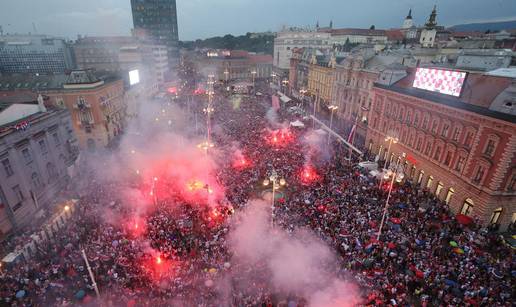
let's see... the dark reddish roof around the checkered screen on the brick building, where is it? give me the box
[375,69,516,123]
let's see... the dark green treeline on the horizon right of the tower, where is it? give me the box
[179,33,274,55]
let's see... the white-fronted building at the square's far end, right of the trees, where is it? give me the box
[273,31,333,70]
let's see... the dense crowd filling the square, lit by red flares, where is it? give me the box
[0,87,516,307]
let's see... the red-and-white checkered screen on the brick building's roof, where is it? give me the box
[412,68,466,97]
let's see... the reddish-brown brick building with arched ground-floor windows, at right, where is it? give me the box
[366,69,516,230]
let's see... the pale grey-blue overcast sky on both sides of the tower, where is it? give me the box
[0,0,516,40]
